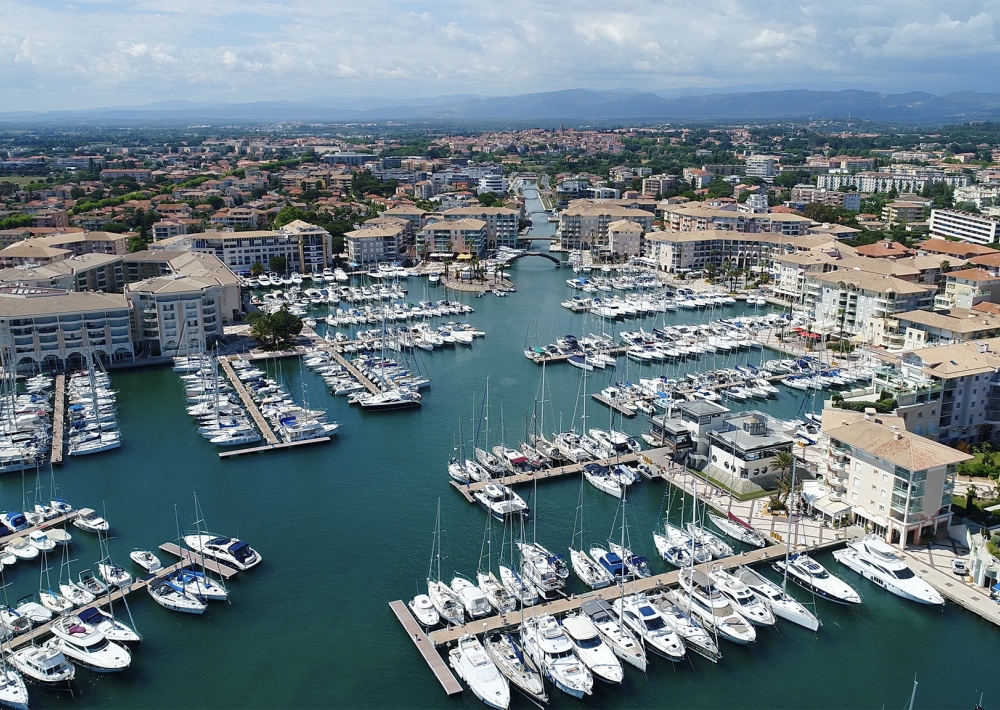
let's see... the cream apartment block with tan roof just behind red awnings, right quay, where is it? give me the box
[806,270,937,346]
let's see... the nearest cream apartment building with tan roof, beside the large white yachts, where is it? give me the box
[823,418,972,547]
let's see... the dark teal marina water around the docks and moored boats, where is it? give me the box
[0,189,1000,708]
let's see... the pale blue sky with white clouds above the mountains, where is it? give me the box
[0,0,1000,111]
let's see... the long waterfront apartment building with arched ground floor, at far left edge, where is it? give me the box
[0,286,134,370]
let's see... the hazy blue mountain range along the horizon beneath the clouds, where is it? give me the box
[0,89,1000,124]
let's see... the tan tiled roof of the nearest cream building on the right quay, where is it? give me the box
[825,419,972,471]
